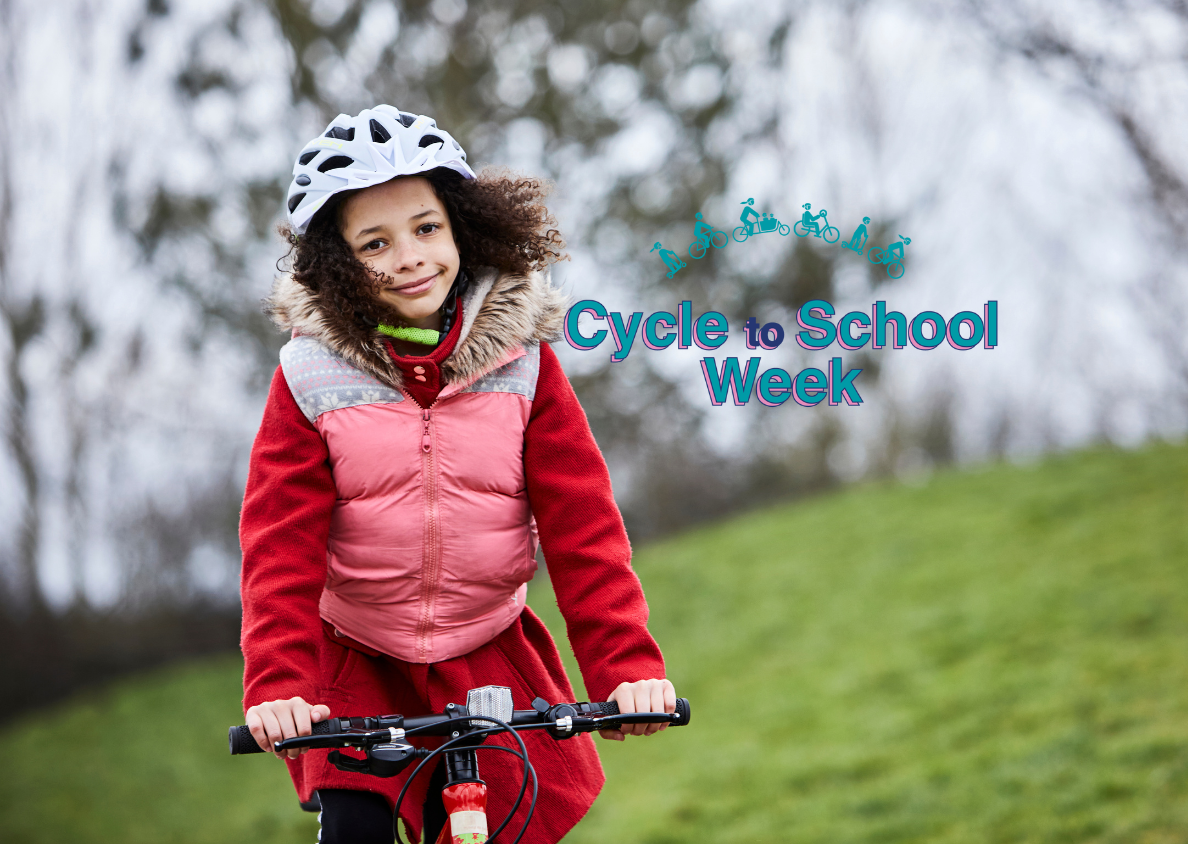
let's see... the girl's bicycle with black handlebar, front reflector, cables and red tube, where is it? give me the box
[227,686,691,844]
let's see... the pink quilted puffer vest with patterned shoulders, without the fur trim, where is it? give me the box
[280,336,539,662]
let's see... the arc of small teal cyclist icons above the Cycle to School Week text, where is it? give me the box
[651,196,911,278]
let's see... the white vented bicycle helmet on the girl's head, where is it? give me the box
[285,106,475,234]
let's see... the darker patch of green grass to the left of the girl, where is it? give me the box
[0,654,317,844]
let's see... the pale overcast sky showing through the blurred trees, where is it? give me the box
[0,0,1188,603]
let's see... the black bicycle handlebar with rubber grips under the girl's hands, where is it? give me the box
[227,698,691,756]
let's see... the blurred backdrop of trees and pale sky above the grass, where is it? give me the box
[0,0,1188,840]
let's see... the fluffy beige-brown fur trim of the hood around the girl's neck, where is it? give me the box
[265,269,567,390]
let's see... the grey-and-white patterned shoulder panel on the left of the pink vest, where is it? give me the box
[280,336,404,422]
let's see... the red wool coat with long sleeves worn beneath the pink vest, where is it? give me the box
[240,272,664,844]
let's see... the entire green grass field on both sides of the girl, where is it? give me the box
[0,445,1188,844]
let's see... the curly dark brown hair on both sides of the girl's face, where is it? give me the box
[278,168,568,333]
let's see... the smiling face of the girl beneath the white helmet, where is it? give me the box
[341,176,460,329]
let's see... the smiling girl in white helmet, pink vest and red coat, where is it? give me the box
[240,106,676,844]
